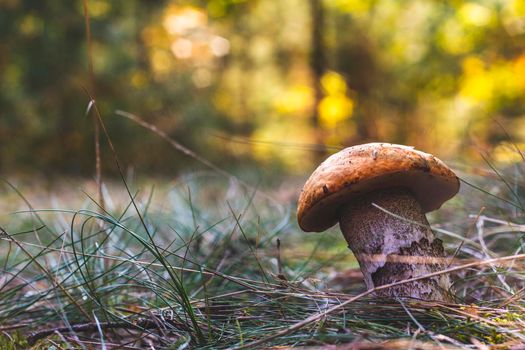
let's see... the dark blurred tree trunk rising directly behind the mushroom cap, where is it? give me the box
[310,0,326,158]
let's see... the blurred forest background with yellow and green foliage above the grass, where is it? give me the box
[0,0,525,176]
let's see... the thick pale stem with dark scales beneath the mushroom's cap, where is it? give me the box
[339,188,451,301]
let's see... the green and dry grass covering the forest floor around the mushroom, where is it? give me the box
[0,165,525,349]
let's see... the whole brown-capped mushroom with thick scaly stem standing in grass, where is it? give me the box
[297,143,459,301]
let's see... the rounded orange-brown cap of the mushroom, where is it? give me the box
[297,143,459,232]
